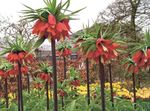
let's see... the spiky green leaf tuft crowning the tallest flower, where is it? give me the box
[22,0,84,21]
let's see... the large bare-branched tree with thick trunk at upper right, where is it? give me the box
[97,0,150,40]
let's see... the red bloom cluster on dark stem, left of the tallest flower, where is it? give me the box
[7,51,33,63]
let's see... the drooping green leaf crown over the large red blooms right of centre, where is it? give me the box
[75,23,125,58]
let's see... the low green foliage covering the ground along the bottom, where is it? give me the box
[0,88,150,111]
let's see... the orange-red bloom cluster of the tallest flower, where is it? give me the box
[32,14,70,40]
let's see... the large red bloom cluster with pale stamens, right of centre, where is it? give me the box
[87,38,119,62]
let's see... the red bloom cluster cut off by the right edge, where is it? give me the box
[132,49,150,68]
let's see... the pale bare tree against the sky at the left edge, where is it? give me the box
[0,17,35,45]
